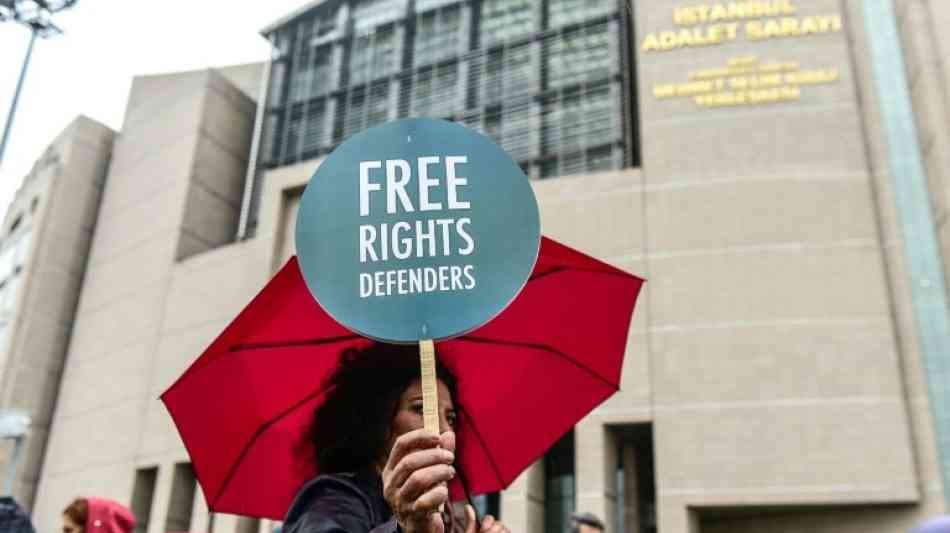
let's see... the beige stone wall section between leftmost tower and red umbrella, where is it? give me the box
[34,70,267,532]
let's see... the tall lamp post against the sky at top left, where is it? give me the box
[0,0,79,165]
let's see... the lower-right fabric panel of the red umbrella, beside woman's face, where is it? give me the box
[439,338,616,494]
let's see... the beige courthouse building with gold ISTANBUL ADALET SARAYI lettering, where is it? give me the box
[1,0,950,533]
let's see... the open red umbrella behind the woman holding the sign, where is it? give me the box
[162,238,643,519]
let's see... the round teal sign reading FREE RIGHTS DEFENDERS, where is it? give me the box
[296,119,541,343]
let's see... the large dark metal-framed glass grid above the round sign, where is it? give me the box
[261,0,635,191]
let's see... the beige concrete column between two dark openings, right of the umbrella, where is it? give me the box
[574,420,617,533]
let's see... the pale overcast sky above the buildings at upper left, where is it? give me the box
[0,0,308,216]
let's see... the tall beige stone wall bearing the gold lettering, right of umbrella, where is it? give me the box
[636,0,929,531]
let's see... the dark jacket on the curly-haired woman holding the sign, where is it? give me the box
[282,472,401,533]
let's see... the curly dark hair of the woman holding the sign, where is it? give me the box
[309,342,460,474]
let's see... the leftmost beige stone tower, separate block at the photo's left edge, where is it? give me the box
[0,116,115,507]
